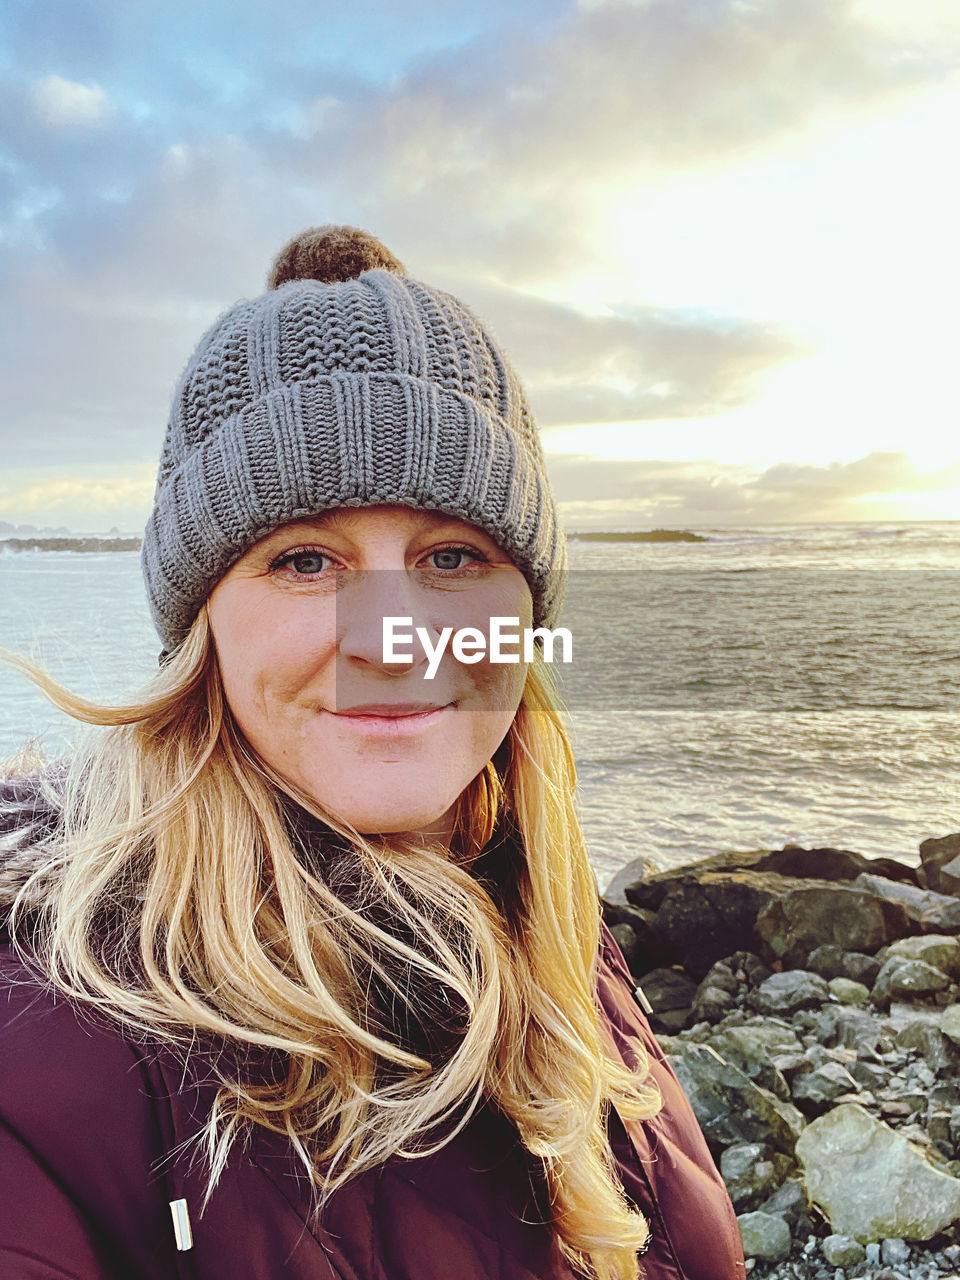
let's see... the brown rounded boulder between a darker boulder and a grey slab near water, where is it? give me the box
[756,881,911,966]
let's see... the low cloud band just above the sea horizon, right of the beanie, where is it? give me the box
[548,452,960,530]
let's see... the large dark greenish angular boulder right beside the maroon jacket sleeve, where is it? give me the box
[668,1041,804,1158]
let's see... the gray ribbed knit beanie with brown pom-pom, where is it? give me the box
[141,227,566,653]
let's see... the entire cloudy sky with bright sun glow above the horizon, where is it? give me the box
[0,0,960,530]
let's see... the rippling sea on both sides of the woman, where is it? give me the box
[0,521,960,888]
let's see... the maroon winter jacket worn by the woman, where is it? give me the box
[0,773,746,1280]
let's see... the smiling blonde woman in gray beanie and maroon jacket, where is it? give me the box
[0,227,745,1280]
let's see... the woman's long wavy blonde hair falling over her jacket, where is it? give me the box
[8,608,662,1280]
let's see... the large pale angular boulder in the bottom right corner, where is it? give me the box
[796,1102,960,1244]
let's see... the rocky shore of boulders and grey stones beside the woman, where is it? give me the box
[604,835,960,1280]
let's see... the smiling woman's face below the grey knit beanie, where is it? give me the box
[209,507,532,842]
